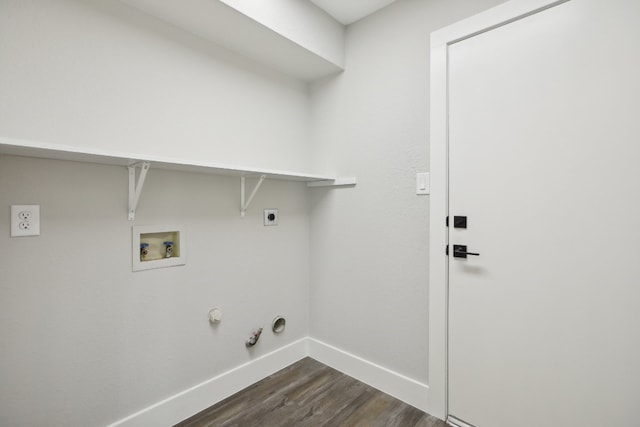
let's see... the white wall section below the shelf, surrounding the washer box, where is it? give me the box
[0,157,309,426]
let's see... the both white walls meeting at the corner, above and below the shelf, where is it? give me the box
[0,0,512,426]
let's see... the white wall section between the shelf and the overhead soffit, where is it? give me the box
[0,0,309,170]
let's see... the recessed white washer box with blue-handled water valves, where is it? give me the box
[131,225,187,271]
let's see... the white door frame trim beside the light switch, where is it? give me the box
[427,0,571,420]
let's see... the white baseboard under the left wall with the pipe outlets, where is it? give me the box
[108,338,308,427]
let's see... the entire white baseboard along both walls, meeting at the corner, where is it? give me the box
[108,337,429,427]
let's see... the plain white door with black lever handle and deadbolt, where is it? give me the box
[448,0,640,427]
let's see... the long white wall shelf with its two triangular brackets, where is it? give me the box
[0,137,356,220]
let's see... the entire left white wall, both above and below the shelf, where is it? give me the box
[0,0,309,426]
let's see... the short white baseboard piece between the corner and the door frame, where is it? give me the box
[308,338,429,412]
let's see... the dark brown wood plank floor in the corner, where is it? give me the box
[176,358,446,427]
